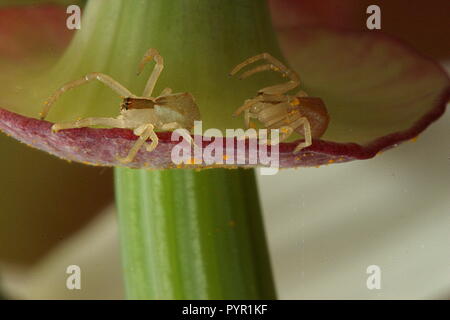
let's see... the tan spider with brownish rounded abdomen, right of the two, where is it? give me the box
[230,53,330,153]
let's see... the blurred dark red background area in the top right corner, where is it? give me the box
[269,0,450,59]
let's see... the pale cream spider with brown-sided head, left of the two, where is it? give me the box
[40,48,200,163]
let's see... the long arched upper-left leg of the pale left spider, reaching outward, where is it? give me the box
[39,72,135,120]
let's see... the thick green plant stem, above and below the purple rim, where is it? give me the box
[50,0,280,299]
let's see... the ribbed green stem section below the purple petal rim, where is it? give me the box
[115,168,275,299]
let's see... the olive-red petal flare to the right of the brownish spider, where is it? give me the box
[279,27,449,149]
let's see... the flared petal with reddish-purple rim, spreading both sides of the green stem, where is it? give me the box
[0,7,450,169]
